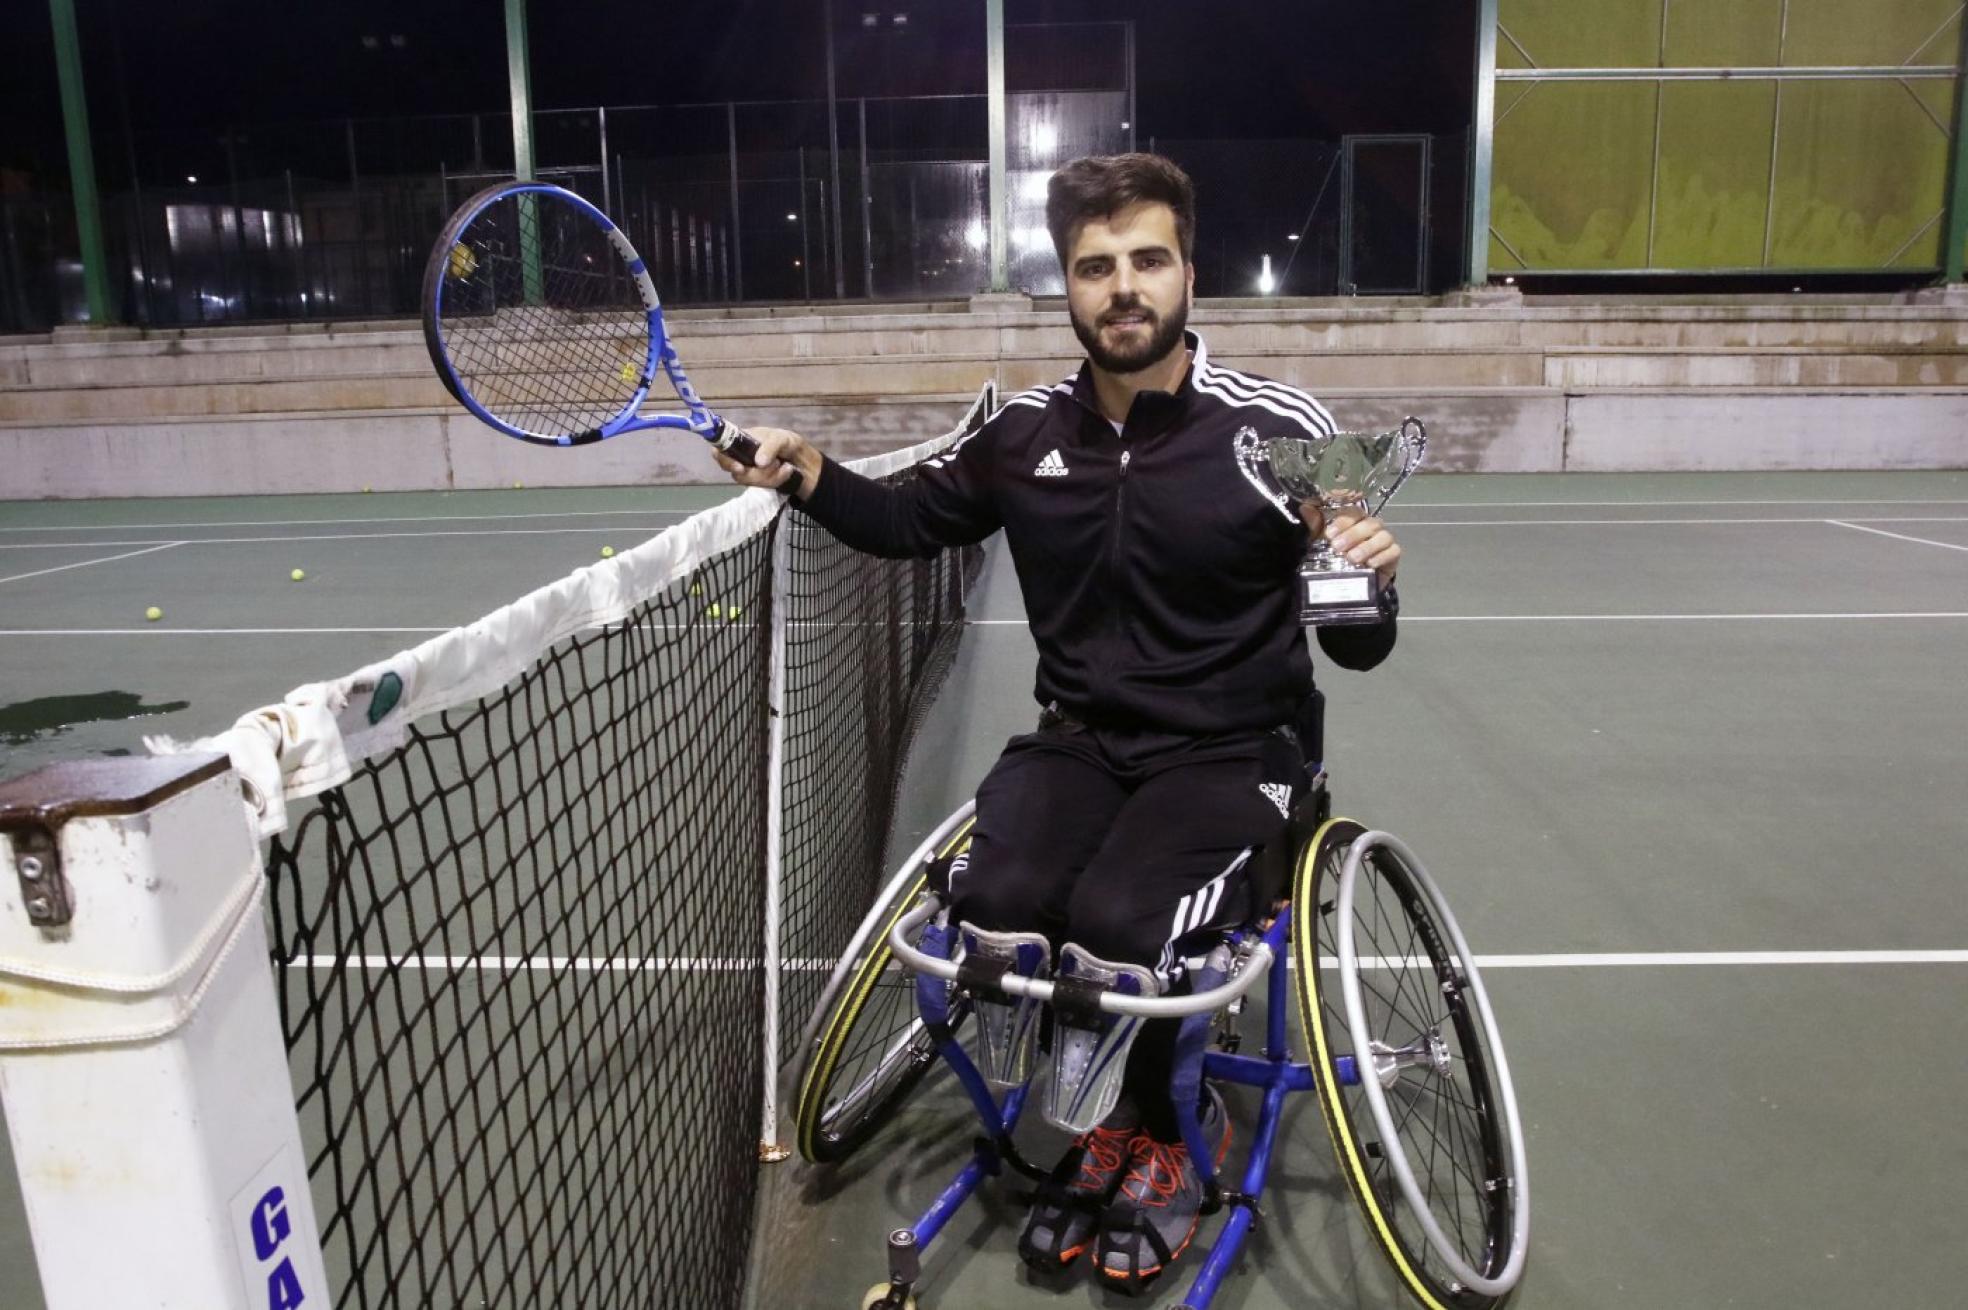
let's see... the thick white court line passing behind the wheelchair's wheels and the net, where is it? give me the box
[287,950,1968,974]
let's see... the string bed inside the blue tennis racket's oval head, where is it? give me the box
[439,195,647,435]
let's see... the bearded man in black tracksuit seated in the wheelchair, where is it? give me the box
[720,153,1401,1288]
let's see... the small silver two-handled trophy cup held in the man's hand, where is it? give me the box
[1236,419,1429,625]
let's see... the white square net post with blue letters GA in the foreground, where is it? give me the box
[0,755,329,1310]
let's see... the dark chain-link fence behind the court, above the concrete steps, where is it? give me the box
[0,24,1464,332]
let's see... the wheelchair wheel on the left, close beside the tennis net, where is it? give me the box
[793,818,972,1164]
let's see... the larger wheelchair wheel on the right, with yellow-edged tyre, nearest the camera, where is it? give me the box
[1291,818,1529,1310]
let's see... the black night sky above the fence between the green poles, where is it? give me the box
[0,0,1476,185]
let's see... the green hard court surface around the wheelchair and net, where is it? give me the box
[0,472,1968,1310]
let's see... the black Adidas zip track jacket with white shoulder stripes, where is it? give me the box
[795,332,1395,734]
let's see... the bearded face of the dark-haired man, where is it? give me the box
[1067,203,1197,374]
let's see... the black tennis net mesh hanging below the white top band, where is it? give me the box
[268,391,988,1310]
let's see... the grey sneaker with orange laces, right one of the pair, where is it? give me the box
[1096,1084,1230,1292]
